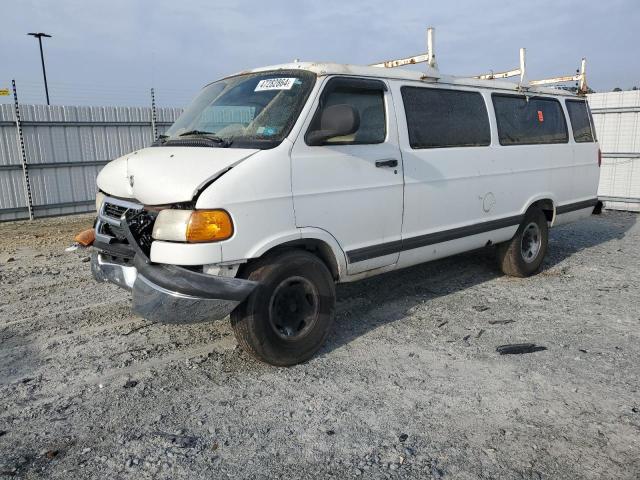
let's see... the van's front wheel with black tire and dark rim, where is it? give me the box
[231,249,336,366]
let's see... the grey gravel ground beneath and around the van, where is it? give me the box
[0,212,640,480]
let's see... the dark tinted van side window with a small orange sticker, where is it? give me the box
[492,94,569,145]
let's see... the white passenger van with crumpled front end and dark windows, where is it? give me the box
[92,63,600,365]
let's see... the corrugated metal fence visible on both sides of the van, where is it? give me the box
[0,91,640,221]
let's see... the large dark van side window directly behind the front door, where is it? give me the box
[401,87,491,149]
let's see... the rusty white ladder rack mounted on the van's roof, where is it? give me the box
[371,27,588,95]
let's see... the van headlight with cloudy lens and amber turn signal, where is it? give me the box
[152,209,233,243]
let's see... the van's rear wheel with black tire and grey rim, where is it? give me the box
[498,208,549,277]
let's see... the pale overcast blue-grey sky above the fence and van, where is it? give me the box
[0,0,640,106]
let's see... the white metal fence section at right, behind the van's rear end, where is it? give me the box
[588,90,640,211]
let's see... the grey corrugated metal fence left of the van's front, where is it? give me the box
[0,105,181,221]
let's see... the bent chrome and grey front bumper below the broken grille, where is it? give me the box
[91,251,257,323]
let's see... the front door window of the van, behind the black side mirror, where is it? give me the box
[309,77,387,145]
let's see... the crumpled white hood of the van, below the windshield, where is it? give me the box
[97,147,259,205]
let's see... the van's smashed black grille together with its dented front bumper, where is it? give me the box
[91,197,257,323]
